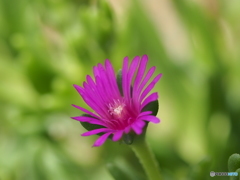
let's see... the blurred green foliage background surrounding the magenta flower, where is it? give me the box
[0,0,240,180]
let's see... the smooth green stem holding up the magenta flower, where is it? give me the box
[130,138,162,180]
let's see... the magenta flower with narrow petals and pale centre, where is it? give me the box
[72,55,162,146]
